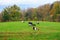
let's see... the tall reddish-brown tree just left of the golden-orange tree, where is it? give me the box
[37,4,50,21]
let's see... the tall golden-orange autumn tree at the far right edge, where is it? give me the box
[50,1,60,21]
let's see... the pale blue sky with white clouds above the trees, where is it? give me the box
[0,0,59,11]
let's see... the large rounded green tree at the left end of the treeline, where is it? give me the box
[2,5,21,21]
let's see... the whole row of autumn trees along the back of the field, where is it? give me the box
[0,1,60,22]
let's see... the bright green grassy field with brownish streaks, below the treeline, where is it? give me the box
[0,21,60,40]
